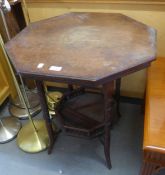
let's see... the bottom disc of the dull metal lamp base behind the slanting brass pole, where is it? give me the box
[9,105,41,119]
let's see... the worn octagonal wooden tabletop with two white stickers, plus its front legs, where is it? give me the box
[6,13,156,168]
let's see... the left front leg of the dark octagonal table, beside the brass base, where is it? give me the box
[36,81,55,154]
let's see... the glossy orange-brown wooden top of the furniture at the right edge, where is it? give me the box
[143,58,165,153]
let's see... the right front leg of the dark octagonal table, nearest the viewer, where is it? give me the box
[103,82,114,169]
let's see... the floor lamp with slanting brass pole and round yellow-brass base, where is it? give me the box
[0,33,49,153]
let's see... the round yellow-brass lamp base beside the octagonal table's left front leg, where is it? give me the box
[17,120,49,153]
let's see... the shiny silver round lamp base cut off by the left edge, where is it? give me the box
[0,117,21,143]
